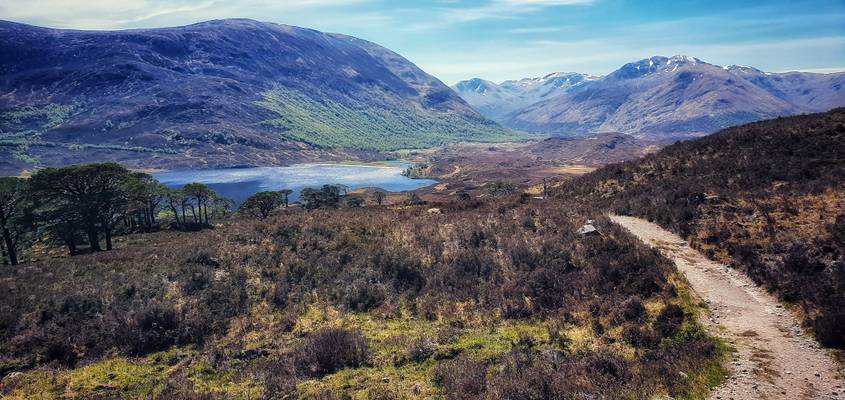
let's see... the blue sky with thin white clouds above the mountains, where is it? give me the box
[0,0,845,84]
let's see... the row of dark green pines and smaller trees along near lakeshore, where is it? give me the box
[0,163,394,265]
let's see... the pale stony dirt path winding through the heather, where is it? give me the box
[611,216,845,400]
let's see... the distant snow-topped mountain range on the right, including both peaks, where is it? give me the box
[453,56,845,137]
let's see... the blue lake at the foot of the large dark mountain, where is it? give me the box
[153,162,437,205]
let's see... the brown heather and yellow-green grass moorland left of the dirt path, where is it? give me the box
[0,166,726,399]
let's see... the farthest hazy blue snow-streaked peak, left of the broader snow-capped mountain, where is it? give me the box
[452,72,596,120]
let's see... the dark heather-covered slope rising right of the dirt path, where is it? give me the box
[559,108,845,348]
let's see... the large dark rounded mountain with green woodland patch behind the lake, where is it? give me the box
[0,19,513,173]
